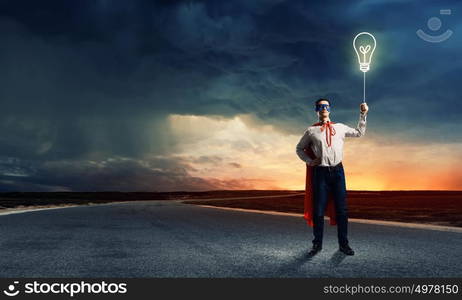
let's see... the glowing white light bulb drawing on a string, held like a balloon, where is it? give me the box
[353,32,377,103]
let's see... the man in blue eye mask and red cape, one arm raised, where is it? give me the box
[296,99,369,256]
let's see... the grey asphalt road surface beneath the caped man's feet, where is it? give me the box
[0,201,462,278]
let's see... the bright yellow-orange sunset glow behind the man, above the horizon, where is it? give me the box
[168,115,462,190]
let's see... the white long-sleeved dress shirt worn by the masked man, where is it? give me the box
[296,114,366,166]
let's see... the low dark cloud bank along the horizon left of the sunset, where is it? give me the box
[0,157,252,192]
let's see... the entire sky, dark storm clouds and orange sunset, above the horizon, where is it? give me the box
[0,0,462,191]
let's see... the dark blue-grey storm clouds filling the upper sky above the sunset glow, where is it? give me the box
[0,0,462,190]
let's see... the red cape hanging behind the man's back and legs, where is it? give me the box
[303,123,337,227]
